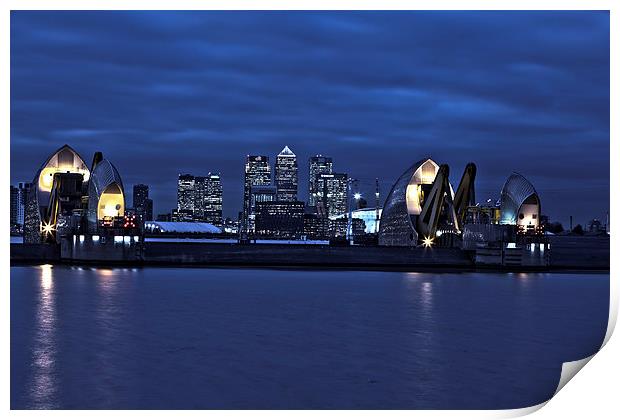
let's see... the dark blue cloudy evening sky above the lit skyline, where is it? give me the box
[11,11,610,223]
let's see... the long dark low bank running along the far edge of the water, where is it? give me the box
[10,237,610,273]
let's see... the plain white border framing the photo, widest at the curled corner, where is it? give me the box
[0,0,620,420]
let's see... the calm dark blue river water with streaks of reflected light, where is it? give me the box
[10,265,609,409]
